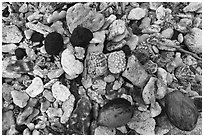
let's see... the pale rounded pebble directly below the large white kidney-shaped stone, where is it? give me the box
[52,81,71,101]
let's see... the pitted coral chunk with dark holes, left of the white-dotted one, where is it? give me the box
[87,52,107,78]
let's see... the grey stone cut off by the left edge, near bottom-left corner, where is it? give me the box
[2,110,15,131]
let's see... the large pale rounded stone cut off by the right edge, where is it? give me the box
[184,28,202,54]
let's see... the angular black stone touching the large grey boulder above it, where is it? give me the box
[70,26,93,48]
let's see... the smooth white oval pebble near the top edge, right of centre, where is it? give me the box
[127,8,146,20]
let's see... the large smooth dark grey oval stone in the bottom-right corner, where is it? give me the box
[165,90,199,131]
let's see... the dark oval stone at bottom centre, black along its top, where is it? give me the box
[98,98,133,128]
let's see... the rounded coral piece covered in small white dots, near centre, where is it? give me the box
[108,50,126,73]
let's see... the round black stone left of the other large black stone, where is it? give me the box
[45,32,64,55]
